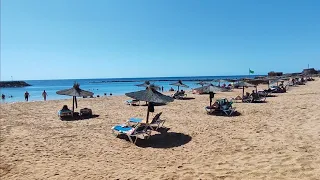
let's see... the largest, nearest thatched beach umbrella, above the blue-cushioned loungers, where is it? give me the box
[125,85,174,123]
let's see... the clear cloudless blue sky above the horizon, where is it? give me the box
[1,0,320,80]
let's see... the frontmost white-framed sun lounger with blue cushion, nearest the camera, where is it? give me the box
[111,123,151,144]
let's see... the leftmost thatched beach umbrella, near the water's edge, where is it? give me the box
[56,83,93,112]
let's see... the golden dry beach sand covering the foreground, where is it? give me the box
[0,79,320,179]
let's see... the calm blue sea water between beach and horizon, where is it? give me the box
[0,76,254,103]
